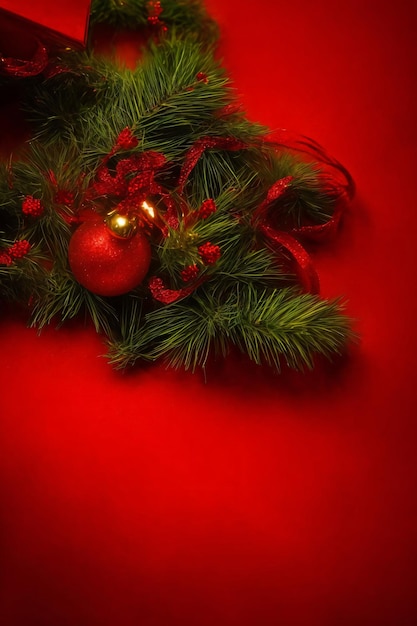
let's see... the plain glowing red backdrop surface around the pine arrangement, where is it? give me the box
[0,0,417,626]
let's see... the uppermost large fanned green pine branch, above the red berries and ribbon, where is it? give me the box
[79,36,237,163]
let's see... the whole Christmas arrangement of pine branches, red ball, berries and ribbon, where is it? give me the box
[0,0,354,370]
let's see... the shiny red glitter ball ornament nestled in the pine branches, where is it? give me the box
[68,221,151,296]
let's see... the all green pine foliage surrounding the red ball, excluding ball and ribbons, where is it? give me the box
[0,0,353,370]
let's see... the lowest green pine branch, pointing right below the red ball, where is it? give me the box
[109,285,353,371]
